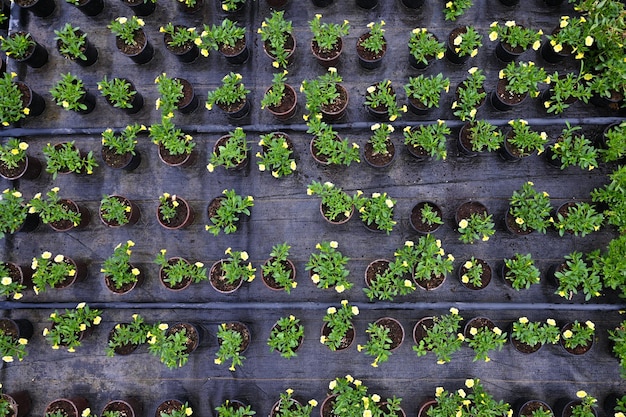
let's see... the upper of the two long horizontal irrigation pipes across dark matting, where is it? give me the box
[0,117,624,137]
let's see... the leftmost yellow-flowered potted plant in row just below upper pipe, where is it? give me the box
[0,138,41,180]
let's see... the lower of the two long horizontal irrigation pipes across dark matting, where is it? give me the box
[0,301,626,311]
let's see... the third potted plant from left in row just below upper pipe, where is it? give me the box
[101,123,148,171]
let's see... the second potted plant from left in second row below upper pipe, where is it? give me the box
[28,187,89,231]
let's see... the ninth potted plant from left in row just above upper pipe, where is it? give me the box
[404,73,450,115]
